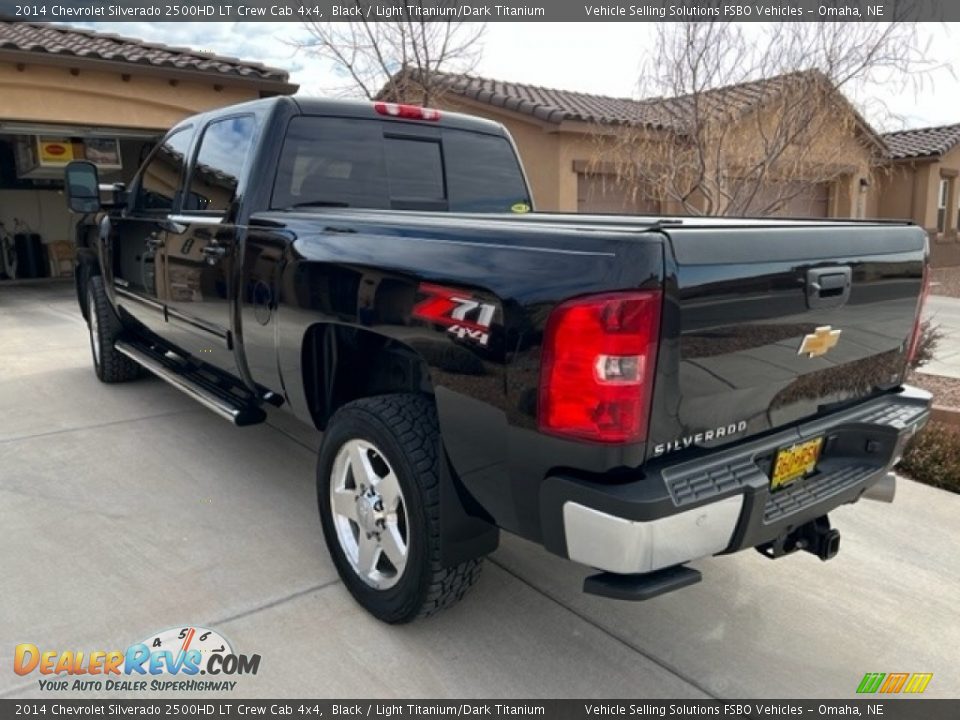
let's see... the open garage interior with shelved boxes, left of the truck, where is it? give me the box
[0,119,157,281]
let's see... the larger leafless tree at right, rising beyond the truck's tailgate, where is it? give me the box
[596,22,935,215]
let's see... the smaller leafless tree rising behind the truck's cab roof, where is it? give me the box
[295,0,486,105]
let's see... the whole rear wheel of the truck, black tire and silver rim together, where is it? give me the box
[317,394,481,623]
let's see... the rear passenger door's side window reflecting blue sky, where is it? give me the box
[183,115,256,215]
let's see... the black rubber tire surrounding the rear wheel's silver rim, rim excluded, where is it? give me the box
[317,394,483,623]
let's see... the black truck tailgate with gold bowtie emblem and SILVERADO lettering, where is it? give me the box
[648,224,926,457]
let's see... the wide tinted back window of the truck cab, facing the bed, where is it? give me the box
[272,117,530,212]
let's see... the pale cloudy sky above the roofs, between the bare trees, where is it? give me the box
[74,22,960,131]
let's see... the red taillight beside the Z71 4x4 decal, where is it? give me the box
[539,292,661,443]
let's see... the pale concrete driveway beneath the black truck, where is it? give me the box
[0,284,960,699]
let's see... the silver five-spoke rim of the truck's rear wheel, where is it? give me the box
[330,440,410,590]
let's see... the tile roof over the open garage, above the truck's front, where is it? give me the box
[0,21,289,83]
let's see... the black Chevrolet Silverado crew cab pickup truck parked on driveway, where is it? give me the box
[66,97,930,622]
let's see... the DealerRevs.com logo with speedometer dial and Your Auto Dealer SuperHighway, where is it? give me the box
[13,627,260,692]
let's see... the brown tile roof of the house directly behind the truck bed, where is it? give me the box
[428,72,822,130]
